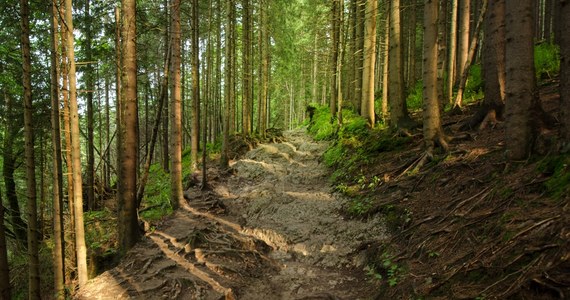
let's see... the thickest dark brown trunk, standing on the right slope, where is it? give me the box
[505,0,538,160]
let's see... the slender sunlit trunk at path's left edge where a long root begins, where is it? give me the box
[170,0,182,209]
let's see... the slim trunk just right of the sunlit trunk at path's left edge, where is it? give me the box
[190,0,200,171]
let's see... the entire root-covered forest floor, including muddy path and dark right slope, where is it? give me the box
[75,82,570,300]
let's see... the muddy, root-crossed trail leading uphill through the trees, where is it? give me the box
[75,130,386,300]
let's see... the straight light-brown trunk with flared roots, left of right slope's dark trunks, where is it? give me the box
[423,0,447,155]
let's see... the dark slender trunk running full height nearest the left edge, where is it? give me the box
[20,0,41,299]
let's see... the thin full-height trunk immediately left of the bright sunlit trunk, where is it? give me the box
[49,0,65,300]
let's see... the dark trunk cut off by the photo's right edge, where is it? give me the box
[559,0,570,152]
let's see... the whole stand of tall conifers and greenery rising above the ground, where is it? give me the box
[0,0,570,299]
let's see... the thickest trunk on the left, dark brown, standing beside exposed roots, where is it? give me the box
[118,0,141,254]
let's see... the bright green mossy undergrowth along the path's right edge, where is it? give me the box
[309,106,411,217]
